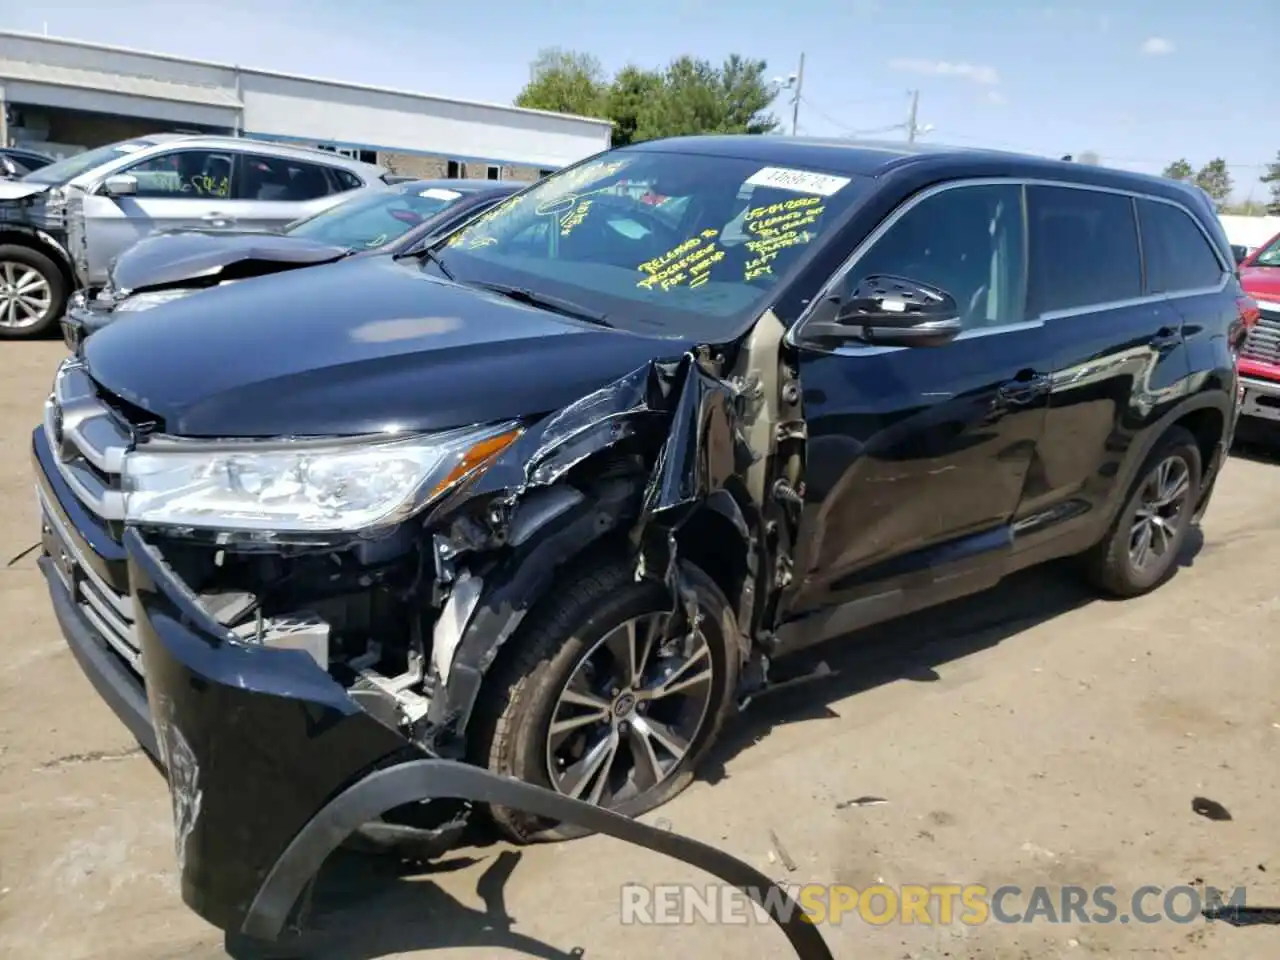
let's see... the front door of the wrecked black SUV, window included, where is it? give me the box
[780,182,1050,645]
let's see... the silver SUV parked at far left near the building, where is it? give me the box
[0,134,387,339]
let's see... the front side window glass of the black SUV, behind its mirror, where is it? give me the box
[849,184,1027,329]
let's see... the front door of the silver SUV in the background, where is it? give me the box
[83,148,236,287]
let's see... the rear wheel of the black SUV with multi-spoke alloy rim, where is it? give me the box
[1087,426,1201,596]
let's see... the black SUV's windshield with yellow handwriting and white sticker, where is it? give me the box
[435,150,858,340]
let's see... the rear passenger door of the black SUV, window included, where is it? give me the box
[1018,184,1190,554]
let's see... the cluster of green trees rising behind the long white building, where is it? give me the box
[516,49,778,146]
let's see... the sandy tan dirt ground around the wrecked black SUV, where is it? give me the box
[0,343,1280,960]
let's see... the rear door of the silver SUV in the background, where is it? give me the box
[236,154,364,230]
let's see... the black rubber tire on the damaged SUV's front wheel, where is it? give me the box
[470,562,740,844]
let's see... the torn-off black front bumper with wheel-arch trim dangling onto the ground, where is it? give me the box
[35,440,831,960]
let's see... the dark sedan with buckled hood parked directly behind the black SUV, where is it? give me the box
[63,180,525,351]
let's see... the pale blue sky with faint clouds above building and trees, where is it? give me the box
[0,0,1280,200]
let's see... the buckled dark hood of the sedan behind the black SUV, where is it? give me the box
[108,230,351,293]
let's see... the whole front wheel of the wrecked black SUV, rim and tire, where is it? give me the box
[474,563,740,842]
